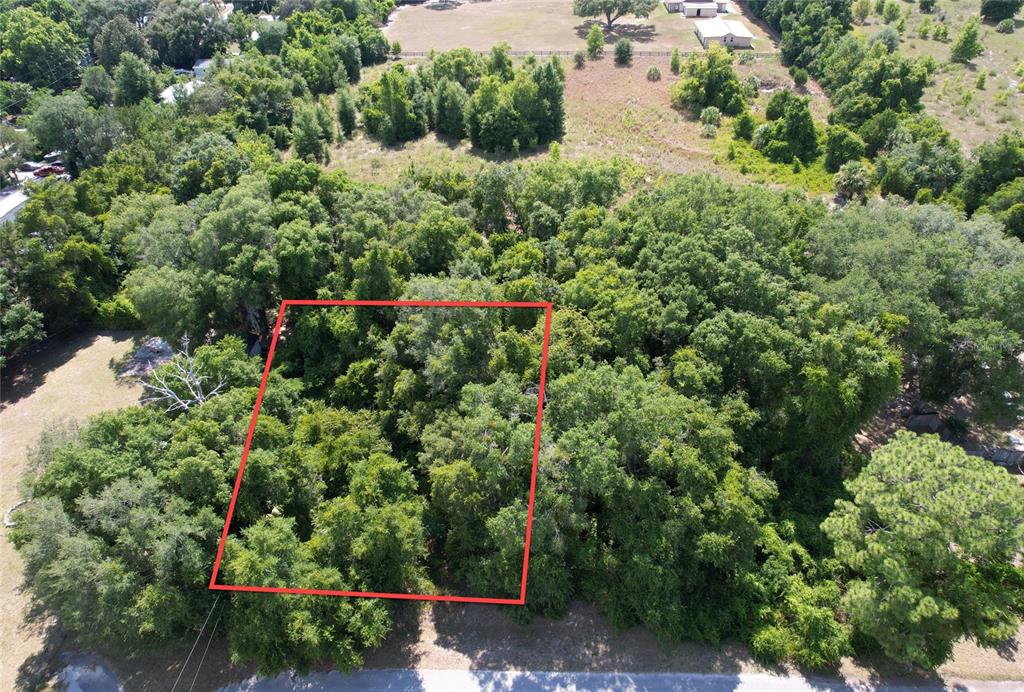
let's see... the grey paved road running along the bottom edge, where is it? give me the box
[220,669,1022,692]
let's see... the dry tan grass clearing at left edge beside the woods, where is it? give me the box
[0,332,141,690]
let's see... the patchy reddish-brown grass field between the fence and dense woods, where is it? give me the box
[329,55,830,193]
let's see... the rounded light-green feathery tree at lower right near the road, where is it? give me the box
[822,431,1024,667]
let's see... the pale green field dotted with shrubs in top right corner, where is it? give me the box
[855,0,1024,150]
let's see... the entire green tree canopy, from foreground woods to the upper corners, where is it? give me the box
[0,0,1024,674]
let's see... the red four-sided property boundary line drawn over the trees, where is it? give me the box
[210,300,552,605]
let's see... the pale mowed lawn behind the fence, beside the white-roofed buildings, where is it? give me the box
[384,0,775,52]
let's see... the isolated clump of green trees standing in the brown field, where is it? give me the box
[360,43,565,153]
